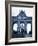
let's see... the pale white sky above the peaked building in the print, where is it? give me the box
[11,7,34,17]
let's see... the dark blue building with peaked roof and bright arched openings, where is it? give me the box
[11,10,32,38]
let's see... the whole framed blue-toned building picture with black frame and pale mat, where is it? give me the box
[5,1,37,44]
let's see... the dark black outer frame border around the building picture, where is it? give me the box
[5,1,37,45]
